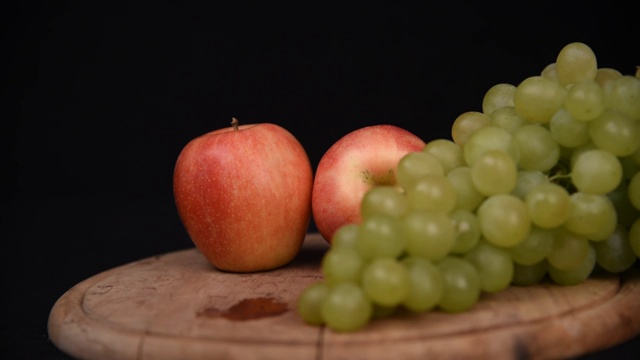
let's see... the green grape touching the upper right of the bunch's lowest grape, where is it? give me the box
[362,257,411,307]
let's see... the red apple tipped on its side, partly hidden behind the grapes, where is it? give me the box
[311,125,426,243]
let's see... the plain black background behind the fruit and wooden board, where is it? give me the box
[0,0,640,359]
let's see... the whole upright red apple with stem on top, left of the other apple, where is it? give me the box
[173,119,313,272]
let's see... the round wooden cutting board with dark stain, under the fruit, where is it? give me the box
[48,234,640,360]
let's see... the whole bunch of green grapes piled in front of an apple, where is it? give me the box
[298,42,640,332]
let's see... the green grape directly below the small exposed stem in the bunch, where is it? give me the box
[524,183,571,229]
